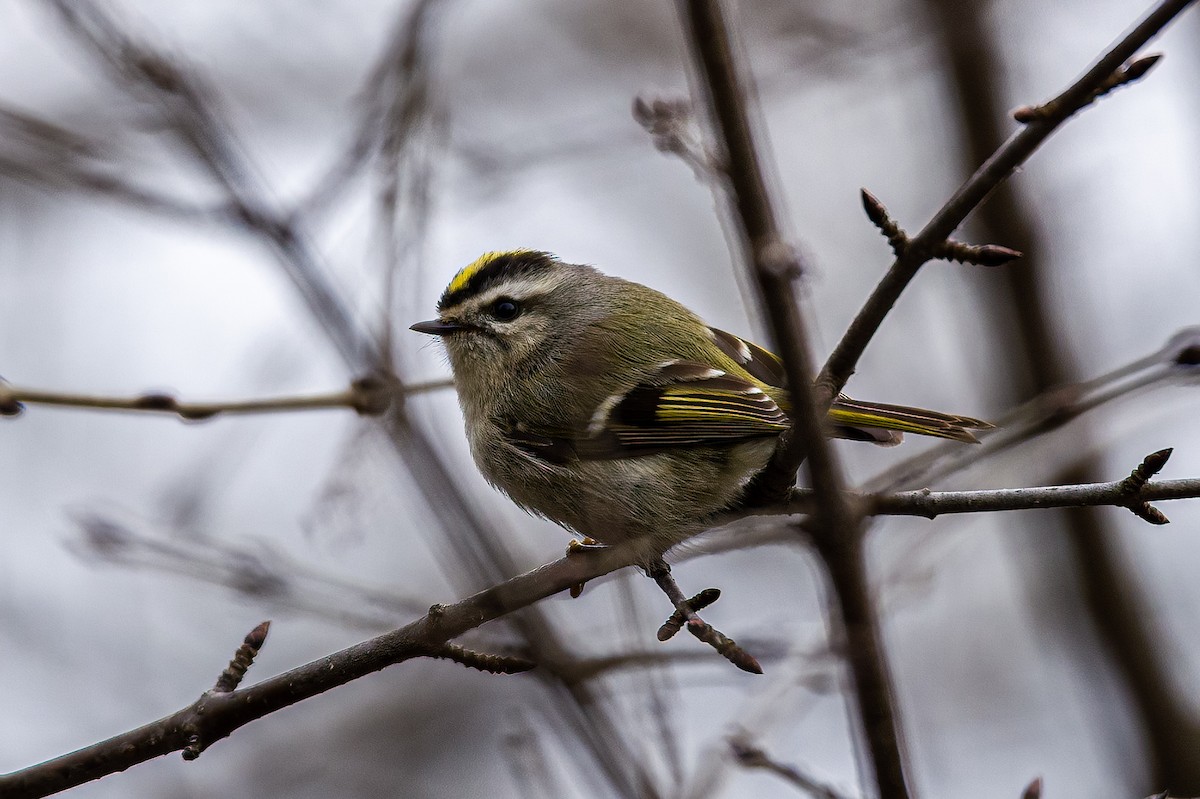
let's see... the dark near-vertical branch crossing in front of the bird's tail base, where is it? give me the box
[679,0,908,799]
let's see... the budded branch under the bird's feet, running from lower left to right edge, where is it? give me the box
[16,451,1200,799]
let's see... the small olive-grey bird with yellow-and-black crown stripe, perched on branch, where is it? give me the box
[412,250,991,547]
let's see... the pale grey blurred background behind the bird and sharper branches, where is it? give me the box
[0,0,1200,799]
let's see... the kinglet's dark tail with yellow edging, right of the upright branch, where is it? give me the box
[829,395,995,446]
